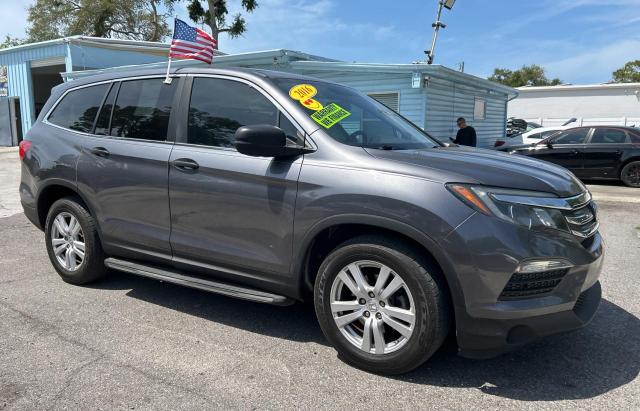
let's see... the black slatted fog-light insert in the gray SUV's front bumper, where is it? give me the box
[498,268,569,300]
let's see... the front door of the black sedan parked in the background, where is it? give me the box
[528,127,591,176]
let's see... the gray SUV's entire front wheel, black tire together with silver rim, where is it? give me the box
[314,236,451,375]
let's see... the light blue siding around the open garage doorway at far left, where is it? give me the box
[0,44,67,133]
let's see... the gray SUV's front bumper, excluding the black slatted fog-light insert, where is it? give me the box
[445,214,604,358]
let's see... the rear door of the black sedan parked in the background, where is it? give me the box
[583,127,631,178]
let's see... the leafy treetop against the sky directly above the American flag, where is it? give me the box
[187,0,258,46]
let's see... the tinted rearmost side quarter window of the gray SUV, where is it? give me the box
[47,84,109,133]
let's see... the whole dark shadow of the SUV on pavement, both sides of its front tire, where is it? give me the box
[94,273,640,401]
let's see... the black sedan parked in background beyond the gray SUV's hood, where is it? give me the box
[499,126,640,187]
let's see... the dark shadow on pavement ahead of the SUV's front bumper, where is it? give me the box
[399,300,640,401]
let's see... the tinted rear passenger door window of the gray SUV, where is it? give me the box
[110,78,177,141]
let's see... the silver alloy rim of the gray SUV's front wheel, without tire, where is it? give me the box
[330,260,416,355]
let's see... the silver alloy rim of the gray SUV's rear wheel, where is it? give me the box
[51,211,85,271]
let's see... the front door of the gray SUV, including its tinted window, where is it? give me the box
[169,77,302,284]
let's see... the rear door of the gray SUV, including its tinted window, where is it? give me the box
[77,78,178,259]
